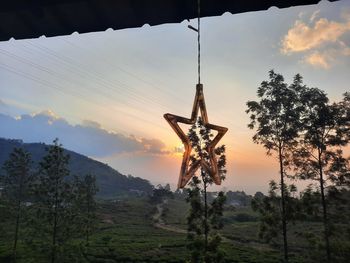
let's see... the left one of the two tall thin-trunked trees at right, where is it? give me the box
[246,70,302,262]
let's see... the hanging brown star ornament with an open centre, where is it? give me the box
[164,84,228,188]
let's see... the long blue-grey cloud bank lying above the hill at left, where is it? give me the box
[0,110,169,157]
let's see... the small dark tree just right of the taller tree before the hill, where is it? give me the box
[74,174,98,245]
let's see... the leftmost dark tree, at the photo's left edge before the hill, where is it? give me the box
[3,148,33,261]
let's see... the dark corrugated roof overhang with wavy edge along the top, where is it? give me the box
[0,0,338,41]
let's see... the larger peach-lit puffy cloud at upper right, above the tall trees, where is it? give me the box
[281,18,350,54]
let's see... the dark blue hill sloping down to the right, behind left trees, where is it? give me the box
[0,138,153,198]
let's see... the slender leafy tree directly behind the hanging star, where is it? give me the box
[186,118,226,262]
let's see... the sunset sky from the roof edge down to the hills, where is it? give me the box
[0,0,350,194]
